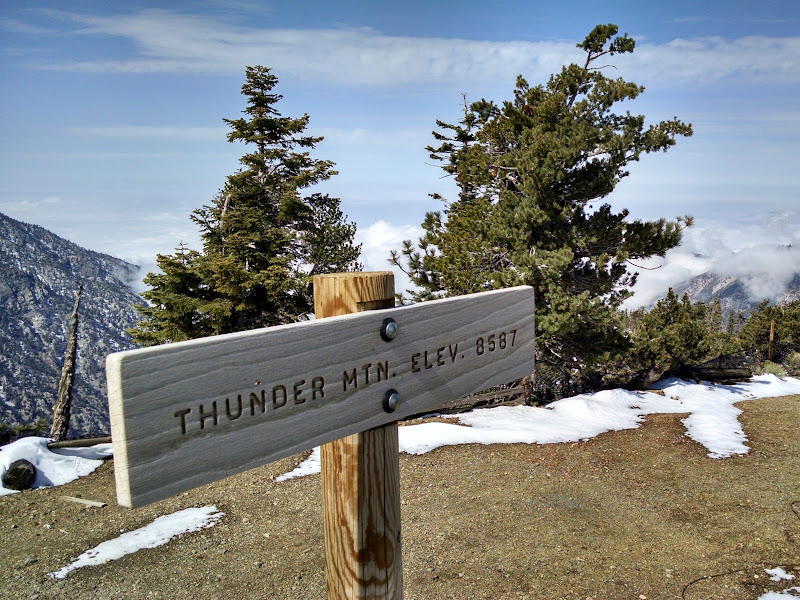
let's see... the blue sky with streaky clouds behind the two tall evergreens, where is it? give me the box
[0,0,800,299]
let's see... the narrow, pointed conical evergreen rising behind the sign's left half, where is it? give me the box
[131,66,360,345]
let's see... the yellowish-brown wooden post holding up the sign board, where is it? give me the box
[314,272,403,600]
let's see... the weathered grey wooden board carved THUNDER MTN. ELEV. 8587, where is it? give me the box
[106,286,534,507]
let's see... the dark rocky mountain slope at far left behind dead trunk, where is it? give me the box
[0,213,141,436]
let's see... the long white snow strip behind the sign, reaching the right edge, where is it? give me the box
[276,375,800,481]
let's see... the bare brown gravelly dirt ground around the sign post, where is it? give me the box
[0,396,800,600]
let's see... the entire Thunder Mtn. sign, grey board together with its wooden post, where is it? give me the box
[106,272,534,600]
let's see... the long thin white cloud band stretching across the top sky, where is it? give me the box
[23,10,800,86]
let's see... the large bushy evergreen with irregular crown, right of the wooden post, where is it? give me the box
[391,25,692,373]
